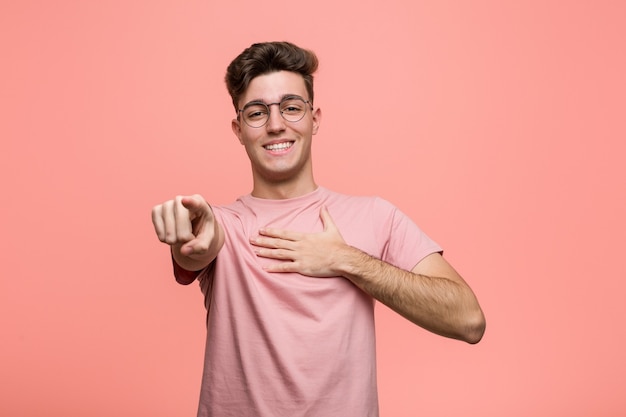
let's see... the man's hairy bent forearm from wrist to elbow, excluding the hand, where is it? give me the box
[336,247,484,343]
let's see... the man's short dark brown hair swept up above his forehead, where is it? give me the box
[225,42,318,111]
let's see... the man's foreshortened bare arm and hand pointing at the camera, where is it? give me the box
[152,194,224,284]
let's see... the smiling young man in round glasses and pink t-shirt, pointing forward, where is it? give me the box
[152,42,485,417]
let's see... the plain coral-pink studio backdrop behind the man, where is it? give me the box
[0,0,626,417]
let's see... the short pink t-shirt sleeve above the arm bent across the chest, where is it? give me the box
[377,199,442,271]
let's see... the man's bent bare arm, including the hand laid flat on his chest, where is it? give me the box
[252,209,485,343]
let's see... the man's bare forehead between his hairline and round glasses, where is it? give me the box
[239,71,308,105]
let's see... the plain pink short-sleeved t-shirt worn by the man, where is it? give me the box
[183,187,441,417]
